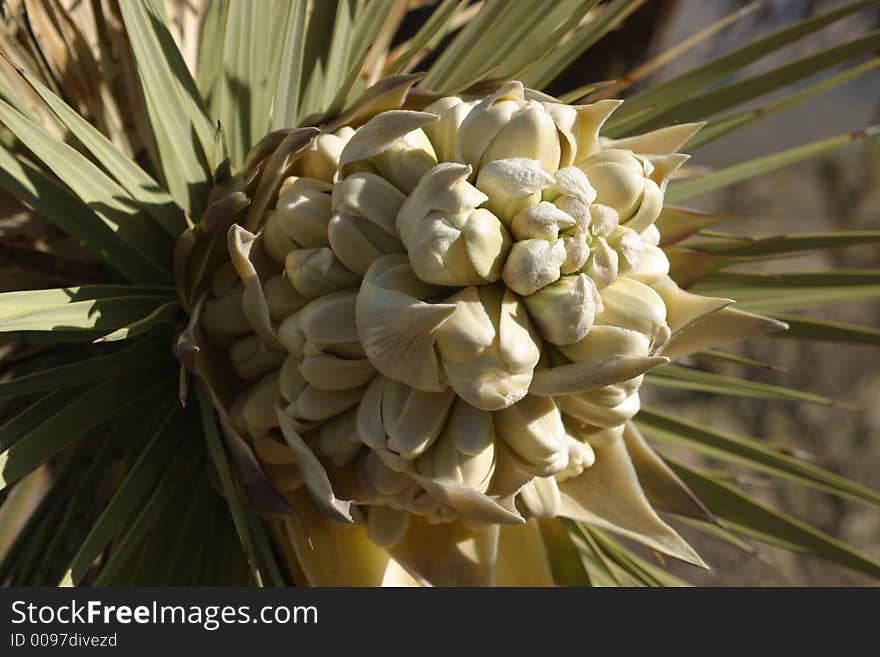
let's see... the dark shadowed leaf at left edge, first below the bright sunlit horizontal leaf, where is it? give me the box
[0,340,171,398]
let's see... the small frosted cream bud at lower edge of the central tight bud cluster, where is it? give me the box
[523,274,602,345]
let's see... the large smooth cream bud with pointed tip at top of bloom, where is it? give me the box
[458,81,561,171]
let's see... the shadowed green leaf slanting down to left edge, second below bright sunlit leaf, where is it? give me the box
[0,367,174,488]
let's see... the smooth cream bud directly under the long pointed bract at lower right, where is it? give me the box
[495,395,568,477]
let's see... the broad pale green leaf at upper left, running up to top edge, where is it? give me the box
[119,0,214,217]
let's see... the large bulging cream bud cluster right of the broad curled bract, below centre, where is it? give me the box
[437,286,541,411]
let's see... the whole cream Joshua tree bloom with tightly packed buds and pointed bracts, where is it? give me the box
[175,79,780,585]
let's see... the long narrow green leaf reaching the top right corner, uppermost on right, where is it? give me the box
[606,0,875,129]
